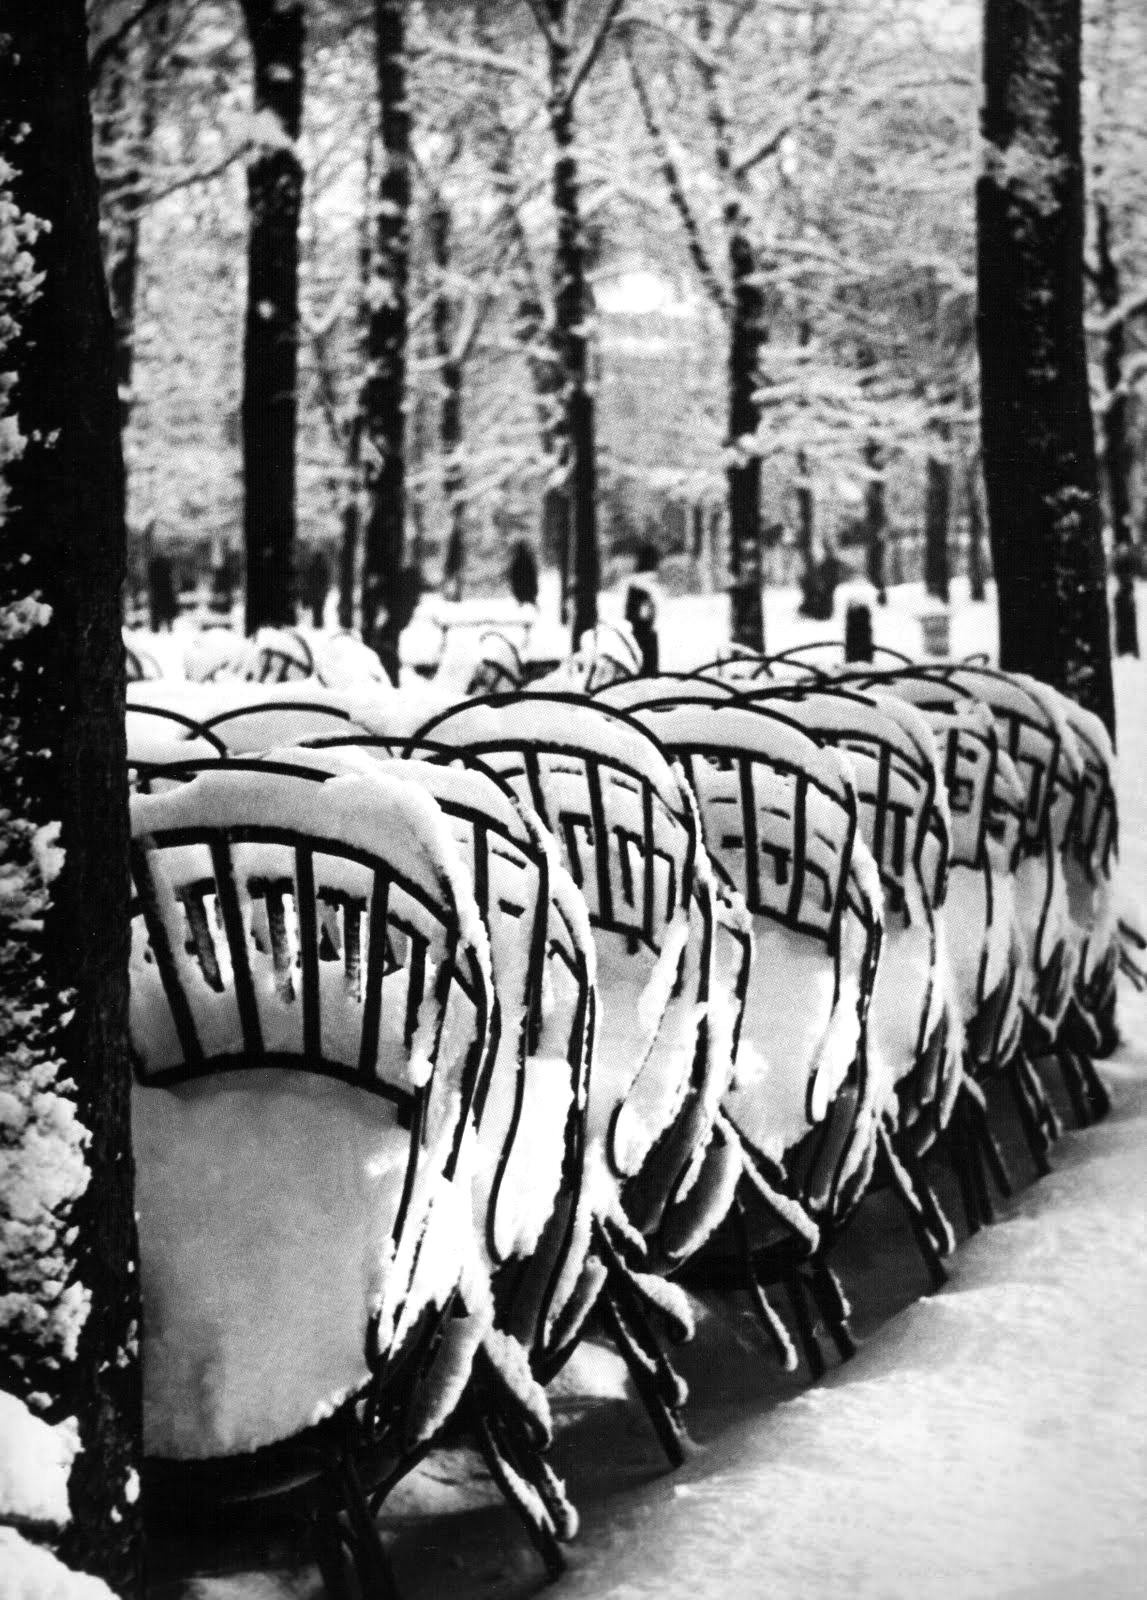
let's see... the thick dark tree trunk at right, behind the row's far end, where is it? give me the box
[976,0,1115,730]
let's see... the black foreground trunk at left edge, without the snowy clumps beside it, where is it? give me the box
[0,0,142,1595]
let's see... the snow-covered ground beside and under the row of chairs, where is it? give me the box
[160,590,1147,1600]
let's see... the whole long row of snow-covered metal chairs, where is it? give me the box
[128,627,1120,1594]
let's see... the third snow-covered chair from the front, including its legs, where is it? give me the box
[413,693,749,1461]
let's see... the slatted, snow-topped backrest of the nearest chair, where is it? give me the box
[131,766,493,1139]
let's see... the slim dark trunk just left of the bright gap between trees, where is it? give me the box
[546,0,600,646]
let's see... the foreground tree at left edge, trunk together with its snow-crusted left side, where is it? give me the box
[0,0,142,1595]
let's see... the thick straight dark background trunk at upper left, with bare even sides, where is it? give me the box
[242,0,302,634]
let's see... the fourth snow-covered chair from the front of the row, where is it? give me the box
[635,702,881,1374]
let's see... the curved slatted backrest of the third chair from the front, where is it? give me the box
[411,693,697,952]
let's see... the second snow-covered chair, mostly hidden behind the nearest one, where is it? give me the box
[270,742,595,1573]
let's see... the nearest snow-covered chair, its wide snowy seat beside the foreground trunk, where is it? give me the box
[130,763,494,1595]
